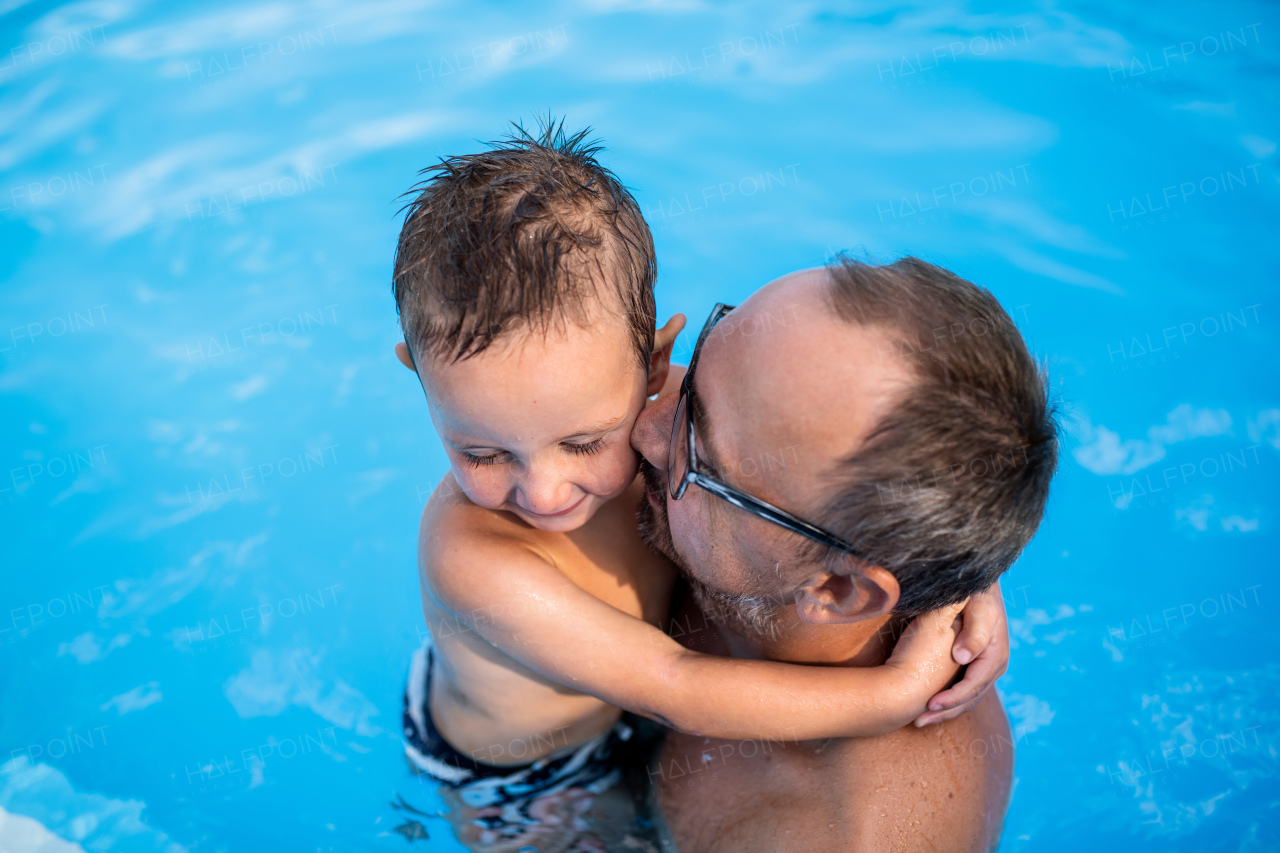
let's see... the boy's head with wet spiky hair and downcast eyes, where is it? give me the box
[394,123,681,530]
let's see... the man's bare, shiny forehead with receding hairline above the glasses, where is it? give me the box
[695,270,909,497]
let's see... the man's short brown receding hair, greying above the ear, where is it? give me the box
[820,257,1057,616]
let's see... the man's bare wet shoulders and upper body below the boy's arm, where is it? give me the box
[652,692,1012,853]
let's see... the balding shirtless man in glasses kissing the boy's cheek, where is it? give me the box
[632,259,1056,853]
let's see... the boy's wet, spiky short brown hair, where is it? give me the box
[393,118,657,366]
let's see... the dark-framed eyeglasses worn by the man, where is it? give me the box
[667,302,860,557]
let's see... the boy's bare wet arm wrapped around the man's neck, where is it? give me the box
[424,527,957,740]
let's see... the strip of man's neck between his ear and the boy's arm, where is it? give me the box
[717,607,902,666]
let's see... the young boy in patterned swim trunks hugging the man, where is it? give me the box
[394,121,1002,808]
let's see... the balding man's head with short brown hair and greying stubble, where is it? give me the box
[632,257,1056,631]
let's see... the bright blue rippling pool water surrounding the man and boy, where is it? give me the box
[0,0,1280,853]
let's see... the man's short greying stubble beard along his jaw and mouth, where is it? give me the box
[636,459,782,642]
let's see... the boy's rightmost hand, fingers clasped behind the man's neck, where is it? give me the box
[915,583,1009,726]
